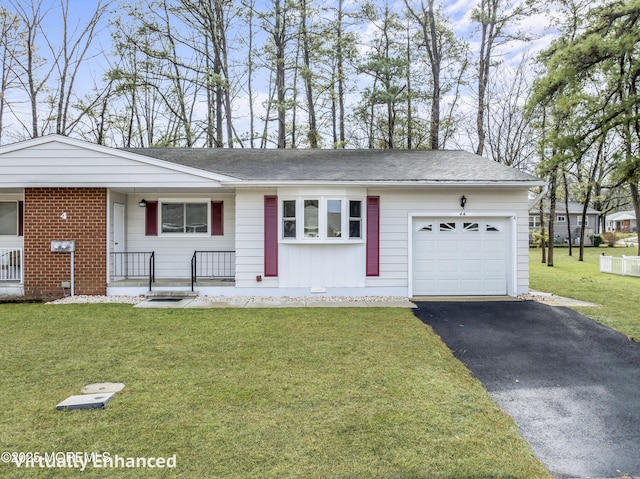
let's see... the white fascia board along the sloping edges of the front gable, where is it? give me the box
[0,135,239,187]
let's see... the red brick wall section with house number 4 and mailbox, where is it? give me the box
[24,188,107,298]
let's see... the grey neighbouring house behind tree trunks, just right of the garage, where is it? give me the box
[529,201,600,245]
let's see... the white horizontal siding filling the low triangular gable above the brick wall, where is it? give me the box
[0,141,218,188]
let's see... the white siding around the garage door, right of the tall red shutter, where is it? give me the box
[366,187,529,294]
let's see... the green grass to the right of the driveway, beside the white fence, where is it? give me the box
[529,247,640,341]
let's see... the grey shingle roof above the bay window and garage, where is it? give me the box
[125,148,541,184]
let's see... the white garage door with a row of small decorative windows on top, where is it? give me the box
[412,217,509,296]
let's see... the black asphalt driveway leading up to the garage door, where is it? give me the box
[414,301,640,478]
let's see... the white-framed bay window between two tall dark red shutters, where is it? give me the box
[280,197,363,242]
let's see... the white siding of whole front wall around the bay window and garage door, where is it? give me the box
[236,188,529,294]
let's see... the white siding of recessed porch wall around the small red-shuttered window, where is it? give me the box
[125,193,235,278]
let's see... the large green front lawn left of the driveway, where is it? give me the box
[0,304,549,479]
